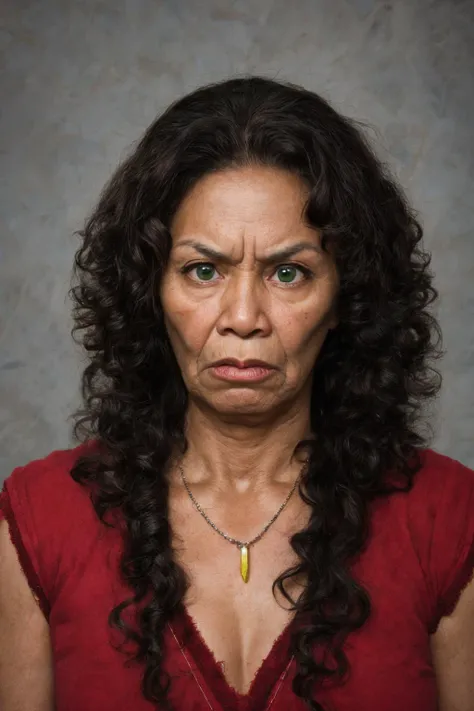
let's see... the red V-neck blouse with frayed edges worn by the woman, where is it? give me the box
[0,445,474,711]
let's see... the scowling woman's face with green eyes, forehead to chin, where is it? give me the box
[161,167,338,415]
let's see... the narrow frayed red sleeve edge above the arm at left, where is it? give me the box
[0,478,49,619]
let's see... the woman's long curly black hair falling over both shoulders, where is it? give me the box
[71,76,443,711]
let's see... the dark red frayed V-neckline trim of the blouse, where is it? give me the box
[172,604,295,711]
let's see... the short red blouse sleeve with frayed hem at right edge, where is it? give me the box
[425,455,474,634]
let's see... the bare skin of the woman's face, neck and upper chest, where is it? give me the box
[161,167,339,691]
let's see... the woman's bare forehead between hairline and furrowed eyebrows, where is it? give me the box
[171,166,316,248]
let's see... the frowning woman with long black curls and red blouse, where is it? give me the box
[0,77,474,711]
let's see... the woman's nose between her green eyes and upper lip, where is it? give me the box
[217,271,271,338]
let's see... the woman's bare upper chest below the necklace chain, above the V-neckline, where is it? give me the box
[168,492,301,694]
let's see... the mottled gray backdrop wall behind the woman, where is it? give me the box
[0,0,474,479]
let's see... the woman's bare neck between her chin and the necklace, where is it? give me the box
[176,403,311,493]
